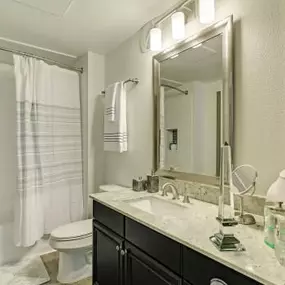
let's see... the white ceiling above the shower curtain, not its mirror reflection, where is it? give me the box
[0,0,178,56]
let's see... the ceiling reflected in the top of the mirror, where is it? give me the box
[161,36,223,85]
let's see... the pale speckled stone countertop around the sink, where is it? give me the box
[90,186,285,285]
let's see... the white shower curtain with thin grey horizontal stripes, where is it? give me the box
[14,55,83,247]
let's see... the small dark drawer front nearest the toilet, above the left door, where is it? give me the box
[93,201,124,237]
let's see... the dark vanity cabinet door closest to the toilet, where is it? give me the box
[93,224,123,285]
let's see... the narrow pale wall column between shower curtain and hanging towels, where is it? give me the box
[77,52,105,216]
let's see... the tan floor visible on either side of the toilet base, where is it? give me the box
[40,251,92,285]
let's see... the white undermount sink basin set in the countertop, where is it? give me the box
[126,197,188,216]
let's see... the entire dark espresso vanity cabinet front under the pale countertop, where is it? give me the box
[93,201,261,285]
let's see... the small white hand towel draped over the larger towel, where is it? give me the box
[104,82,120,122]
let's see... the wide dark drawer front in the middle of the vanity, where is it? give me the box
[126,218,181,274]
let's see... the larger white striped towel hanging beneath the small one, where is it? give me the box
[104,82,128,153]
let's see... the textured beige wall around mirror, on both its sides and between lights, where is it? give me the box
[105,0,285,194]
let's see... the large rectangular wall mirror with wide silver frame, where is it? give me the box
[153,16,233,185]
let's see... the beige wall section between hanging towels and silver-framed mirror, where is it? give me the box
[104,31,153,186]
